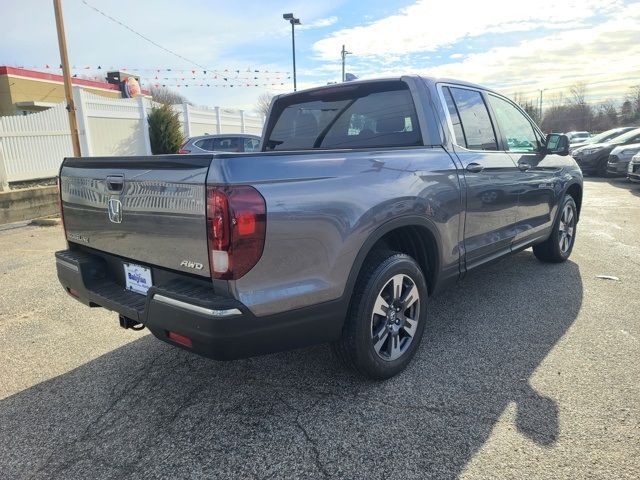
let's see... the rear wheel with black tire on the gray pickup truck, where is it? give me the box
[333,250,429,380]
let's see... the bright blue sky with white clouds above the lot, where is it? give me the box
[0,0,640,110]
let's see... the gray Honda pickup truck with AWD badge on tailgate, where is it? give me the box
[55,76,582,379]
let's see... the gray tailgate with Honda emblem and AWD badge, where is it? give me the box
[60,155,213,276]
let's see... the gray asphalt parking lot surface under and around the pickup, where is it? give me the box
[0,179,640,480]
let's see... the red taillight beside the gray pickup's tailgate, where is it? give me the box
[207,186,267,280]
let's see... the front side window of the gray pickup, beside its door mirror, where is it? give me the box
[489,95,539,153]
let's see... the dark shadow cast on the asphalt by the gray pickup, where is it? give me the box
[0,251,583,480]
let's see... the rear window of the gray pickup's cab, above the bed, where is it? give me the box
[265,82,422,150]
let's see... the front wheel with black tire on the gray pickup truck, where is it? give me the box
[533,195,578,263]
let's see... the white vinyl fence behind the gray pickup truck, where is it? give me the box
[0,87,263,191]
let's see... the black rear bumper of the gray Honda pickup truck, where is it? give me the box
[55,250,344,360]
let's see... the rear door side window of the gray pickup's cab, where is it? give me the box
[444,87,498,150]
